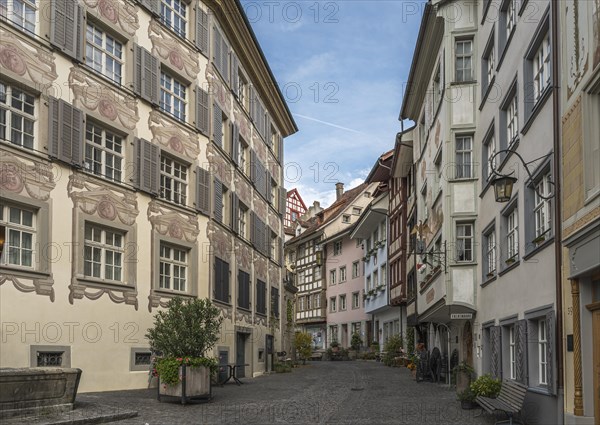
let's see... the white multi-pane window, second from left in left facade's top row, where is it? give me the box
[85,23,123,84]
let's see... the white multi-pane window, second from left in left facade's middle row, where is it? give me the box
[85,122,123,182]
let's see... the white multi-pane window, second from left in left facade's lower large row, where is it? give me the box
[83,223,125,282]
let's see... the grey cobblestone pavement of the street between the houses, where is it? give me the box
[83,361,494,425]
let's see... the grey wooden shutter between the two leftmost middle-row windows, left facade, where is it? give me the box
[48,97,85,168]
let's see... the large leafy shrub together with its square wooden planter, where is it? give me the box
[146,297,223,404]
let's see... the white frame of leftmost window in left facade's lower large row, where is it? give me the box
[0,203,38,264]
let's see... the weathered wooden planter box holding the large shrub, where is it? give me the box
[158,365,212,404]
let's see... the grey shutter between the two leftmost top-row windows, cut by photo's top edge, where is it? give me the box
[50,0,81,59]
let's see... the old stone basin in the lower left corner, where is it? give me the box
[0,367,81,420]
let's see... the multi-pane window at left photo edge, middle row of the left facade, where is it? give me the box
[0,82,36,149]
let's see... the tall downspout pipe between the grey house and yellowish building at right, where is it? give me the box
[550,1,564,423]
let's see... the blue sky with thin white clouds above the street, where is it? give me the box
[242,0,424,206]
